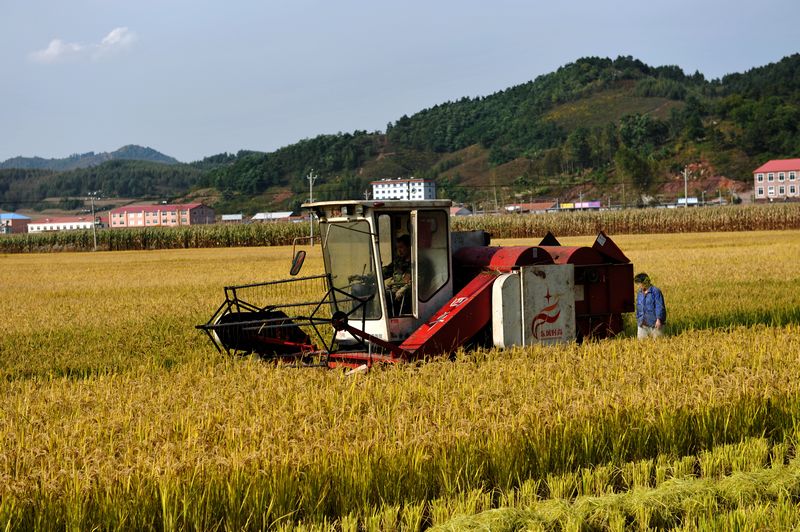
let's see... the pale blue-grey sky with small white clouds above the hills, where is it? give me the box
[0,0,800,162]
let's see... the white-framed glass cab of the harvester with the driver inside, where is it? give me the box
[303,201,453,346]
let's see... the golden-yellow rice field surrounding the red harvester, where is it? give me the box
[0,230,800,530]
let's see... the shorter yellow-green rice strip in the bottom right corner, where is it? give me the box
[438,438,800,531]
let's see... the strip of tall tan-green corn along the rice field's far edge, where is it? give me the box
[0,203,800,253]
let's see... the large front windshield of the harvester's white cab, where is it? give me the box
[321,220,381,319]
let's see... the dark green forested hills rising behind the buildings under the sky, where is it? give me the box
[0,54,800,212]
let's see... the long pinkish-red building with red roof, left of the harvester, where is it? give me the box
[109,203,214,229]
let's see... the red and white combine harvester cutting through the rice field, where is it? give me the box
[197,200,634,368]
